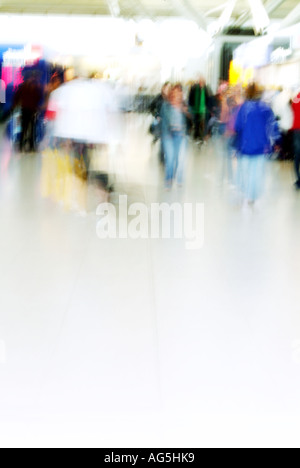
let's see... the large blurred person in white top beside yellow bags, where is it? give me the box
[44,71,116,215]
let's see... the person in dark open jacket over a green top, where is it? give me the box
[188,78,212,142]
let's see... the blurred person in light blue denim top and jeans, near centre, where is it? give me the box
[161,84,190,189]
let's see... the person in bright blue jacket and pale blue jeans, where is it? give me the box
[235,84,276,204]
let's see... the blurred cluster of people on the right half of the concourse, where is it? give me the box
[150,77,300,204]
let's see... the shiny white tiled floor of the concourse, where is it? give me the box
[0,117,300,448]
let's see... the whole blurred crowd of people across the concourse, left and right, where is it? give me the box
[3,66,300,210]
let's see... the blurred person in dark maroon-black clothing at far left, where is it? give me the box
[13,75,43,152]
